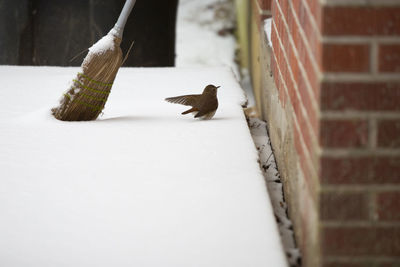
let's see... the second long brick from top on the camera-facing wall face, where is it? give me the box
[321,82,400,111]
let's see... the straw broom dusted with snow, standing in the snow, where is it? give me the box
[51,0,136,121]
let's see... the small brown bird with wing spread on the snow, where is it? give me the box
[165,84,219,120]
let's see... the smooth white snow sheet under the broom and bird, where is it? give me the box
[0,66,286,267]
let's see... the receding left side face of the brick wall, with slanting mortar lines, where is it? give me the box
[266,1,321,266]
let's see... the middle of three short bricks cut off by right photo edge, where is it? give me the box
[377,120,400,148]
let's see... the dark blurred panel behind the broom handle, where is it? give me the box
[0,0,178,67]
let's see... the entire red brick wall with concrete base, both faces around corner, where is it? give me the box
[248,0,400,267]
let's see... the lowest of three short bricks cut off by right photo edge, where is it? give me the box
[376,192,400,221]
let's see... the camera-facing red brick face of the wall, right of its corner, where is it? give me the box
[318,0,400,266]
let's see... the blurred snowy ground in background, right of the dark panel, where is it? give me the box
[176,0,237,73]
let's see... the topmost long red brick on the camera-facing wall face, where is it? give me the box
[320,6,400,36]
